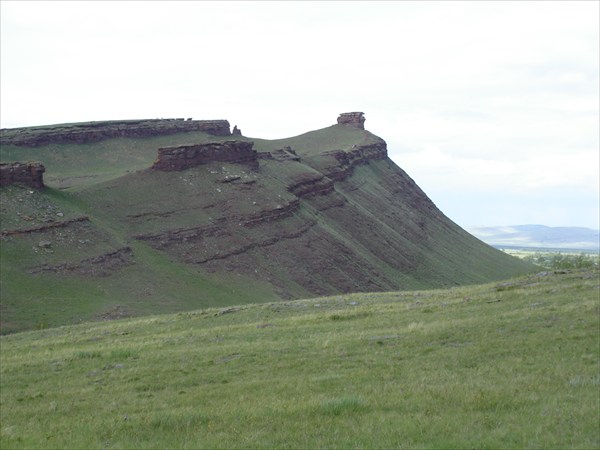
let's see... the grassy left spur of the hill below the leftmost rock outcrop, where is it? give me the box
[0,186,278,333]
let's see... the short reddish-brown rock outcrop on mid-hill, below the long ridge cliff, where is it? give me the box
[152,141,258,171]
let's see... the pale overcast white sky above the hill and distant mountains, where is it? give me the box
[0,0,600,229]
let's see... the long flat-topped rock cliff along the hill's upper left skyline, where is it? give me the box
[0,119,231,147]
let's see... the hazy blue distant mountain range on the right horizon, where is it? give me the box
[467,225,600,251]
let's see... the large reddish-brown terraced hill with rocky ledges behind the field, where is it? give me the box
[0,113,532,332]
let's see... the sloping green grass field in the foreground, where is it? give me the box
[0,270,600,449]
